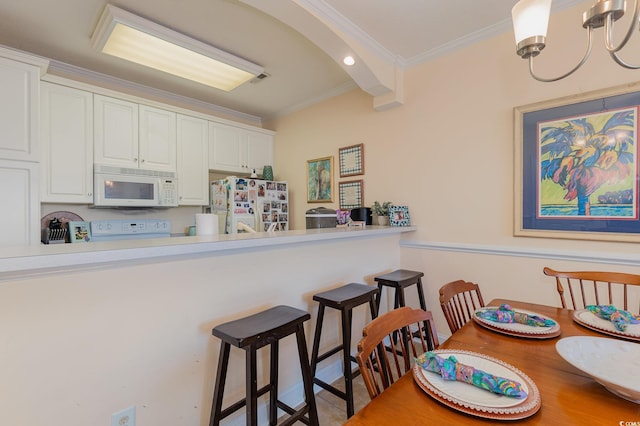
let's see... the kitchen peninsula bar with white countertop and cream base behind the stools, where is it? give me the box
[0,226,416,425]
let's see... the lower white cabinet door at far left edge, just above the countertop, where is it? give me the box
[0,160,40,247]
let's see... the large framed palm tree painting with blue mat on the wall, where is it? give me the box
[514,85,640,241]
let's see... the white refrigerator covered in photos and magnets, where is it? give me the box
[211,176,289,234]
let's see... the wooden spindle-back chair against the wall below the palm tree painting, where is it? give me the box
[543,267,640,314]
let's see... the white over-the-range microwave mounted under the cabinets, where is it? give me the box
[93,164,178,207]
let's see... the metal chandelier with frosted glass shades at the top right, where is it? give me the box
[511,0,640,82]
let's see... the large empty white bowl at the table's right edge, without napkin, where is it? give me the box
[556,336,640,404]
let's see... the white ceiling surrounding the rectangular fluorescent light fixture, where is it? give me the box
[0,0,581,120]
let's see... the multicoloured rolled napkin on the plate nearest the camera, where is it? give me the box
[416,352,527,399]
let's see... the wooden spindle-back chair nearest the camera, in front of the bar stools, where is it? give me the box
[356,306,440,399]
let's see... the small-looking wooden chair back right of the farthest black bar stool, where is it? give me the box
[440,280,484,334]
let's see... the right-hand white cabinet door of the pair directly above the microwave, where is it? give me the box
[139,105,176,172]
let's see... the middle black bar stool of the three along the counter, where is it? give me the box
[311,283,380,418]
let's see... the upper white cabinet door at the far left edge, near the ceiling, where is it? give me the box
[0,58,40,162]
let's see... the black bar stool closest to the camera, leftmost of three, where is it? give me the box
[209,305,318,426]
